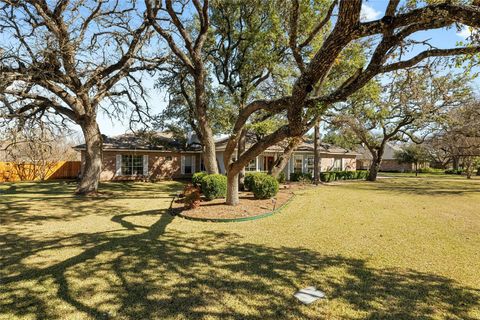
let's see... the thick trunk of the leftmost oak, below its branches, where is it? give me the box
[76,119,103,194]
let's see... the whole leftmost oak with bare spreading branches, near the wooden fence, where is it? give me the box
[0,0,162,194]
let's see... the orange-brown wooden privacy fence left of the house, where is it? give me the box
[0,161,81,182]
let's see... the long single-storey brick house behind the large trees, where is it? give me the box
[74,132,357,181]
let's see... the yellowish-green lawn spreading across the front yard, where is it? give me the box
[0,176,480,320]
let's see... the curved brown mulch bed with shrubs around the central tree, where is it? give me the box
[171,184,305,220]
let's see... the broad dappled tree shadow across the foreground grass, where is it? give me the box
[0,211,480,319]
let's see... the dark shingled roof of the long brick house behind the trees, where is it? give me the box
[74,131,358,155]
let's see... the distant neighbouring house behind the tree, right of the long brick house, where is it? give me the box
[357,142,415,172]
